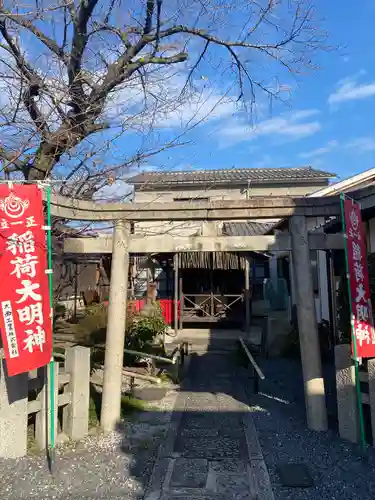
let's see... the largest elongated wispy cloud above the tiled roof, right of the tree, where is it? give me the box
[220,109,321,145]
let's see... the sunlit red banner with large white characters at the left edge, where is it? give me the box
[0,184,52,376]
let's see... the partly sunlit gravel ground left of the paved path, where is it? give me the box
[0,390,177,500]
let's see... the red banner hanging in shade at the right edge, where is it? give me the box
[344,199,375,358]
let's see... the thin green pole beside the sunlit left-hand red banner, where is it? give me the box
[46,186,56,472]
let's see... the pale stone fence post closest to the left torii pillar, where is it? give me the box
[63,346,90,440]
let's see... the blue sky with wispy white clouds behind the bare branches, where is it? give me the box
[0,0,375,201]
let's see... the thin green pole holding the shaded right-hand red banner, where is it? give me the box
[340,193,366,454]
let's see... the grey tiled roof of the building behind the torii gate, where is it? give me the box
[127,167,336,189]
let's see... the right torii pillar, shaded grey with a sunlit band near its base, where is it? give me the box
[289,215,328,431]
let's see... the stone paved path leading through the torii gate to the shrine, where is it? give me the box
[145,353,274,500]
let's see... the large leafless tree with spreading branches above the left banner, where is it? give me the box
[0,0,325,197]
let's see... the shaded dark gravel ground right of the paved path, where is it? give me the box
[245,359,375,500]
